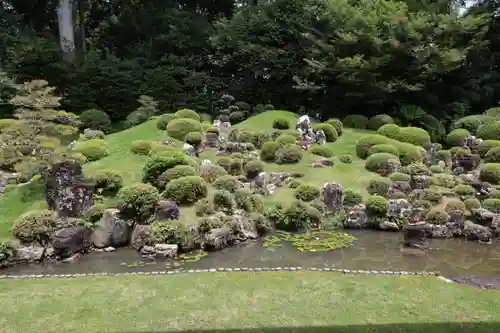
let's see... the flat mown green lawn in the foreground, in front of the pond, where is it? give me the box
[0,272,500,333]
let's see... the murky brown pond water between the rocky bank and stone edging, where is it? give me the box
[2,231,500,276]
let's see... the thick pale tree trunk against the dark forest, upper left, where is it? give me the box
[57,0,75,62]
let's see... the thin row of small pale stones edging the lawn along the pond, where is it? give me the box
[0,267,441,280]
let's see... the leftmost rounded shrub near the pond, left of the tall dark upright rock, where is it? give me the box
[12,209,59,243]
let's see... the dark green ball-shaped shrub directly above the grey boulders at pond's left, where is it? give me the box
[117,183,160,222]
